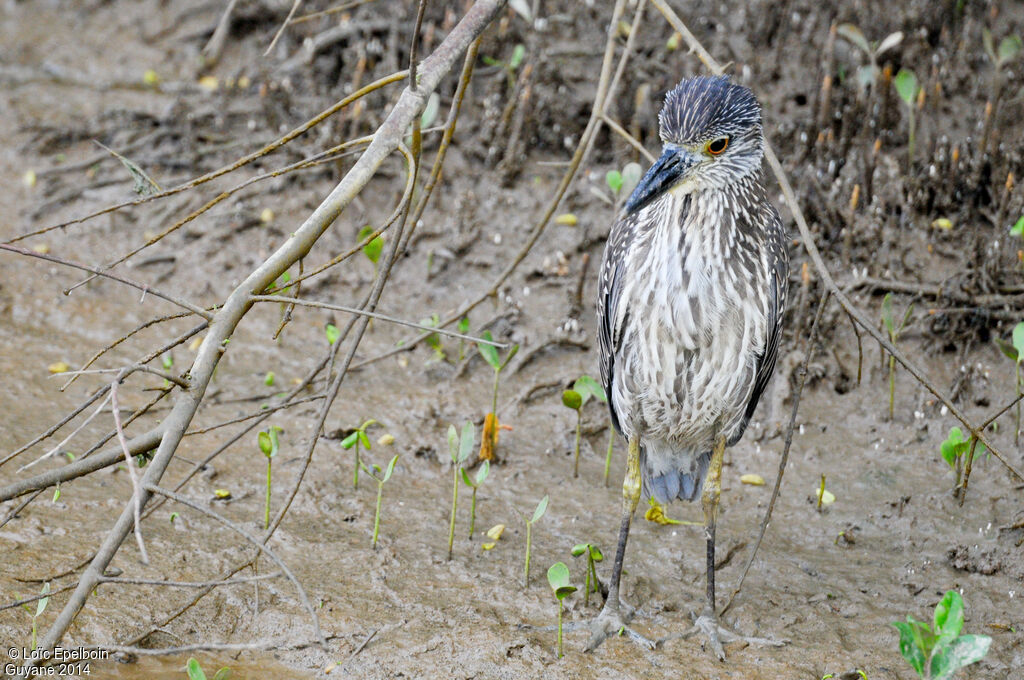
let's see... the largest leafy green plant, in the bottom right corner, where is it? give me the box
[893,590,992,680]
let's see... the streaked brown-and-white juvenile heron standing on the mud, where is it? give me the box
[588,76,790,660]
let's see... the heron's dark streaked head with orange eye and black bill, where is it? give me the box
[626,76,764,213]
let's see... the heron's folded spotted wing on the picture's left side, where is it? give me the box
[597,212,639,432]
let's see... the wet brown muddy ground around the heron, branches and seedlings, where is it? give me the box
[0,0,1024,680]
